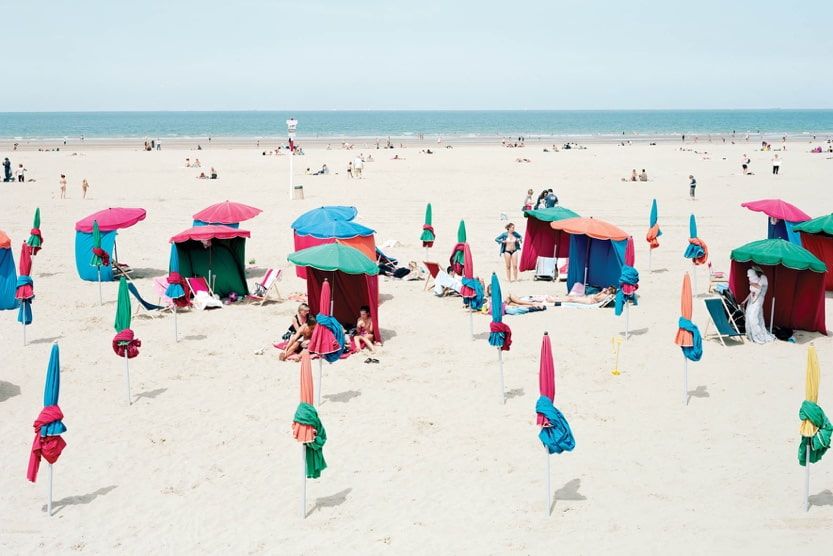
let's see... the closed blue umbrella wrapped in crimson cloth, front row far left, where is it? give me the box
[26,343,67,516]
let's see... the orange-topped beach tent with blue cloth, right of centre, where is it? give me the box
[550,218,628,291]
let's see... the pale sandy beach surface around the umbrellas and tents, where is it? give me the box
[0,142,833,554]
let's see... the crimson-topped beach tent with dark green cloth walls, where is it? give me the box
[170,225,251,297]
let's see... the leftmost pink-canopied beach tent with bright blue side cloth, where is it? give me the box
[75,208,147,282]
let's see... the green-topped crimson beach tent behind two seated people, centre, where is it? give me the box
[287,243,382,342]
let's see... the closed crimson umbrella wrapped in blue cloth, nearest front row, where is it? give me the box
[535,332,576,515]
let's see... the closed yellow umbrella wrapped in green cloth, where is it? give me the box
[798,344,833,510]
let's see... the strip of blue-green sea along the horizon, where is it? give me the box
[0,109,833,140]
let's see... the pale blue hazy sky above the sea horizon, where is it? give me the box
[6,0,833,111]
